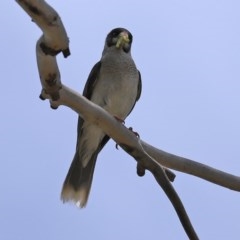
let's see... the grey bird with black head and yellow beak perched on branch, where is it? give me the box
[61,28,142,207]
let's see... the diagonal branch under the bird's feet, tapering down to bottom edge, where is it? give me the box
[56,85,198,239]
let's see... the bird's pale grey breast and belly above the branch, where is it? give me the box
[91,51,139,119]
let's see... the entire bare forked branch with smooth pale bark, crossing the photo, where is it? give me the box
[16,0,240,239]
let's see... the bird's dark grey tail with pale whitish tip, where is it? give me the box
[61,151,97,208]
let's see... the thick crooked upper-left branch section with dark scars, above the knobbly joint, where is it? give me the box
[16,0,70,100]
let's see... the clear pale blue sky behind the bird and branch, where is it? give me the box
[0,0,240,240]
